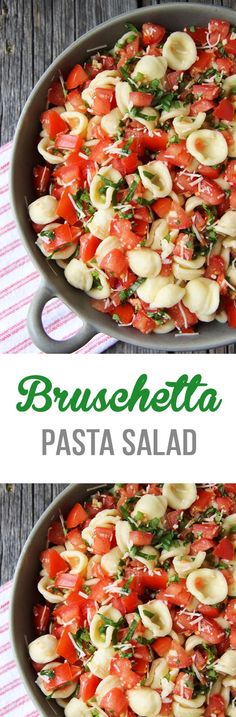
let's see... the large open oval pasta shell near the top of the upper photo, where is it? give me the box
[162,32,197,71]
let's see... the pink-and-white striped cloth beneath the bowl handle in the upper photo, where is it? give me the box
[0,142,115,353]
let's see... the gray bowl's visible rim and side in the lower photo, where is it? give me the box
[10,483,107,717]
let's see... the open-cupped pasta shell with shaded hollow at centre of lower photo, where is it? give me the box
[138,600,172,637]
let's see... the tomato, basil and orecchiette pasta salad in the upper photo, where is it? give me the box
[29,19,236,333]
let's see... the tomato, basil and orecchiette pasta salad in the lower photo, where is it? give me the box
[28,483,236,717]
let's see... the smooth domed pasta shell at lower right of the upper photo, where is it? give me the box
[183,277,220,315]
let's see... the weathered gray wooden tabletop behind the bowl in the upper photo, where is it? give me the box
[0,0,236,354]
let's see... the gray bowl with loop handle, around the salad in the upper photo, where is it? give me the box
[11,3,236,353]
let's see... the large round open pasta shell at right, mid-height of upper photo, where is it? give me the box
[186,129,228,167]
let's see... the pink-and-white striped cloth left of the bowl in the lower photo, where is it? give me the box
[0,582,40,717]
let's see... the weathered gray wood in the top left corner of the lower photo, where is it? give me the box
[0,483,65,584]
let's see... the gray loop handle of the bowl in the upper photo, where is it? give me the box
[27,284,96,354]
